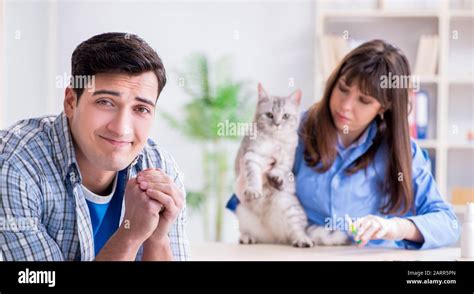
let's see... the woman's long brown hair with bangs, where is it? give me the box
[301,40,413,214]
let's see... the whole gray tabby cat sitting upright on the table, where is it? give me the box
[235,84,348,247]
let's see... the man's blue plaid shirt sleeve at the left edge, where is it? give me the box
[0,159,64,261]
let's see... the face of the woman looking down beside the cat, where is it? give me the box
[329,77,382,135]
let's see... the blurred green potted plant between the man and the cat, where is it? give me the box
[161,53,252,241]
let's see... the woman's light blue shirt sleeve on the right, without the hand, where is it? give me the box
[400,141,460,249]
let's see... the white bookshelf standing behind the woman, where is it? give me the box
[314,0,474,213]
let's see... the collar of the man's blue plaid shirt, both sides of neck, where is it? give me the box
[51,112,143,183]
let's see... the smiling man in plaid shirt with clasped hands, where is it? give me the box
[0,33,189,261]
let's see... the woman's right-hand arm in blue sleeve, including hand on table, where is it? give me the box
[355,142,460,249]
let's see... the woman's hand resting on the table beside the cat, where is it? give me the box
[354,215,423,247]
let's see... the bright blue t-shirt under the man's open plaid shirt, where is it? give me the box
[86,170,126,256]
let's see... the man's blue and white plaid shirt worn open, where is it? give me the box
[0,113,189,261]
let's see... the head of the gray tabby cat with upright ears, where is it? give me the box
[255,83,301,134]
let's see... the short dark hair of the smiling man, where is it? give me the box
[71,33,166,102]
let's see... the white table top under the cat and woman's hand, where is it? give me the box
[191,242,474,261]
